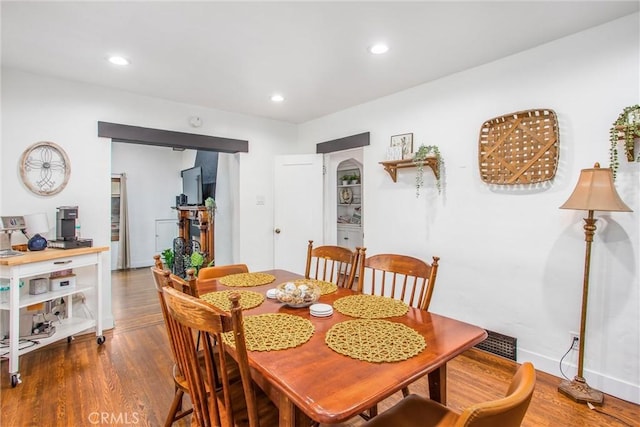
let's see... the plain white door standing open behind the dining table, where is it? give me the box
[273,154,323,274]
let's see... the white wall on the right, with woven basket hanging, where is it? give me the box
[300,14,640,403]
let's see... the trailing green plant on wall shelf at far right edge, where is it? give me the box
[609,104,640,179]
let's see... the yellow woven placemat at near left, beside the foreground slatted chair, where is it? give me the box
[222,313,314,351]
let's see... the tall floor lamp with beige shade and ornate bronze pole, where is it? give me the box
[558,163,631,405]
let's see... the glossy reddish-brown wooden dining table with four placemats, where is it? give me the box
[198,270,487,427]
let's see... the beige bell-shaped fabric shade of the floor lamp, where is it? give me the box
[560,163,632,212]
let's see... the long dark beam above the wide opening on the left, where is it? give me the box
[98,122,249,153]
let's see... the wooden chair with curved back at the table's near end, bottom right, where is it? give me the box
[364,362,536,427]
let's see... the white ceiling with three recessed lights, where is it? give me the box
[1,0,640,123]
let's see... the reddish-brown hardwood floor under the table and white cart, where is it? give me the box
[0,268,640,427]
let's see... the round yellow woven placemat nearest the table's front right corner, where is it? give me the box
[325,319,427,363]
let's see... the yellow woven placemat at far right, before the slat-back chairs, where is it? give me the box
[333,295,409,319]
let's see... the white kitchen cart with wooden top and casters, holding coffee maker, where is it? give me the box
[0,246,109,387]
